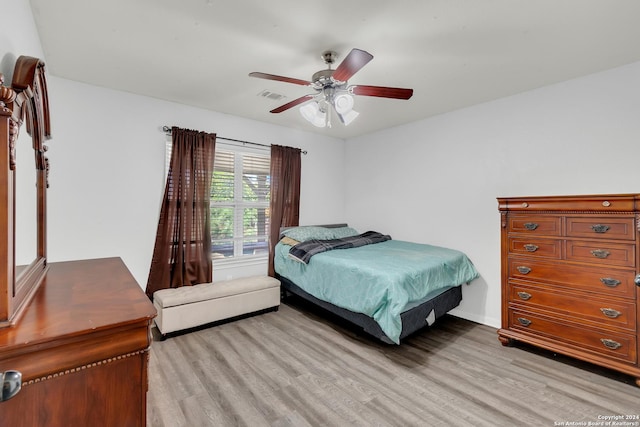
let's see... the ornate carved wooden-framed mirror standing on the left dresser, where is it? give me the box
[0,56,51,327]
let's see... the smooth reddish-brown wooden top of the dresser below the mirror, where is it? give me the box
[0,258,156,359]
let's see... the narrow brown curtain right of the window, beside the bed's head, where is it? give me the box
[269,145,302,277]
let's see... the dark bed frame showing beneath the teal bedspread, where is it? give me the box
[276,224,462,344]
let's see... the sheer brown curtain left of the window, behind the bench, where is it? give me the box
[146,127,216,299]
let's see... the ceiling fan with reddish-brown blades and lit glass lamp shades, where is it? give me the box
[249,49,413,127]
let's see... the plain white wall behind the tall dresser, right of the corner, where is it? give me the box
[345,63,640,326]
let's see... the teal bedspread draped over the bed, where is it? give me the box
[274,240,478,344]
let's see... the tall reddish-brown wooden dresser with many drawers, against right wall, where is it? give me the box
[498,194,640,386]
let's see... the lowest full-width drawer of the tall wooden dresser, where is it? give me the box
[509,309,637,363]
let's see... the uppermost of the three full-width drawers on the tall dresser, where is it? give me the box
[508,258,636,300]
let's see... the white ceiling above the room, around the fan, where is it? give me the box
[31,0,640,138]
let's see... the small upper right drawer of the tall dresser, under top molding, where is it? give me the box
[566,217,636,240]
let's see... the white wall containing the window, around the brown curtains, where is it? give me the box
[48,77,344,287]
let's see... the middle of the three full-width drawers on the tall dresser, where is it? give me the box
[510,284,636,332]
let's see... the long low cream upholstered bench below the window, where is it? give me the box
[153,276,280,336]
